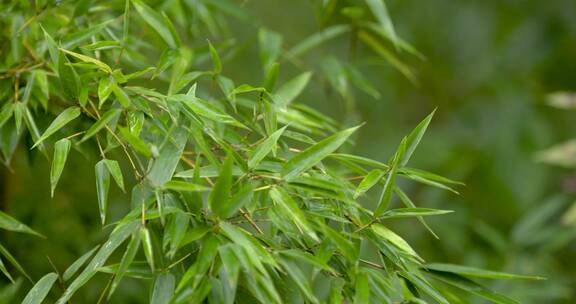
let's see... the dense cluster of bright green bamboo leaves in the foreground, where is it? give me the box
[0,0,535,304]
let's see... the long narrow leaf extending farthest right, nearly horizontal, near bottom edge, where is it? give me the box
[425,263,546,280]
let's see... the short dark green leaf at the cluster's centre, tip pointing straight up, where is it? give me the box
[208,155,234,217]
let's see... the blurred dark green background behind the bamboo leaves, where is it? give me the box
[0,0,576,303]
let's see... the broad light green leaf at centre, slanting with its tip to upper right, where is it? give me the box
[282,126,359,181]
